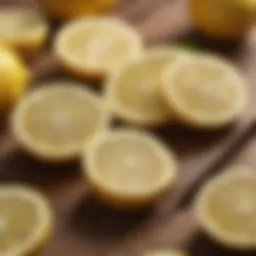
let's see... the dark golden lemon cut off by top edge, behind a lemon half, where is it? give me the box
[41,0,117,20]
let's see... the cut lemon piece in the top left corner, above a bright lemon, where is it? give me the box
[0,7,49,54]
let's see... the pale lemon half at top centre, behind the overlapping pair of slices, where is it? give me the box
[55,18,142,80]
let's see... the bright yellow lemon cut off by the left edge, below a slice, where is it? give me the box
[0,45,30,111]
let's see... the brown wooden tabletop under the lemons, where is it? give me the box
[0,0,256,256]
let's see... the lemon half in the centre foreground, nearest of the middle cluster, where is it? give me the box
[83,130,177,209]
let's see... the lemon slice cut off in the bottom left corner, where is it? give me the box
[0,185,53,256]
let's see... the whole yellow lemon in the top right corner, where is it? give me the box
[189,0,256,40]
